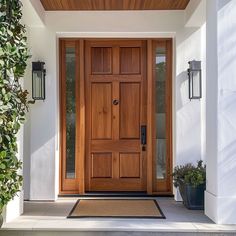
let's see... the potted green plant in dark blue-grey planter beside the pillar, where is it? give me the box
[172,160,206,210]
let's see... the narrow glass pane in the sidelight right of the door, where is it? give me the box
[155,47,166,179]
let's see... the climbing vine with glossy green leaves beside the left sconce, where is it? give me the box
[0,0,30,212]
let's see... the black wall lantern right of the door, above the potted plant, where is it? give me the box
[188,60,202,100]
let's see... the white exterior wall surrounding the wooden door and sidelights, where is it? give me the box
[20,1,204,200]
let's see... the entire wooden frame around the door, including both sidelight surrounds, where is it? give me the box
[59,38,173,195]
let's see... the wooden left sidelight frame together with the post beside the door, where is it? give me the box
[59,39,85,194]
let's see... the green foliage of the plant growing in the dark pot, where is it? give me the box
[172,160,206,187]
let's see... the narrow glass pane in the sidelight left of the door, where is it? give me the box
[66,47,75,179]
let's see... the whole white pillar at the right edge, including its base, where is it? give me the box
[205,0,236,224]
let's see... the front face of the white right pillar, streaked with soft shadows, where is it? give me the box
[217,0,236,223]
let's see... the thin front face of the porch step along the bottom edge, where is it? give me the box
[0,229,236,236]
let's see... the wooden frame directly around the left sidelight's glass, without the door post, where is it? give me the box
[59,40,82,193]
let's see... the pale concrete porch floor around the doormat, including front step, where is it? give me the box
[0,197,236,236]
